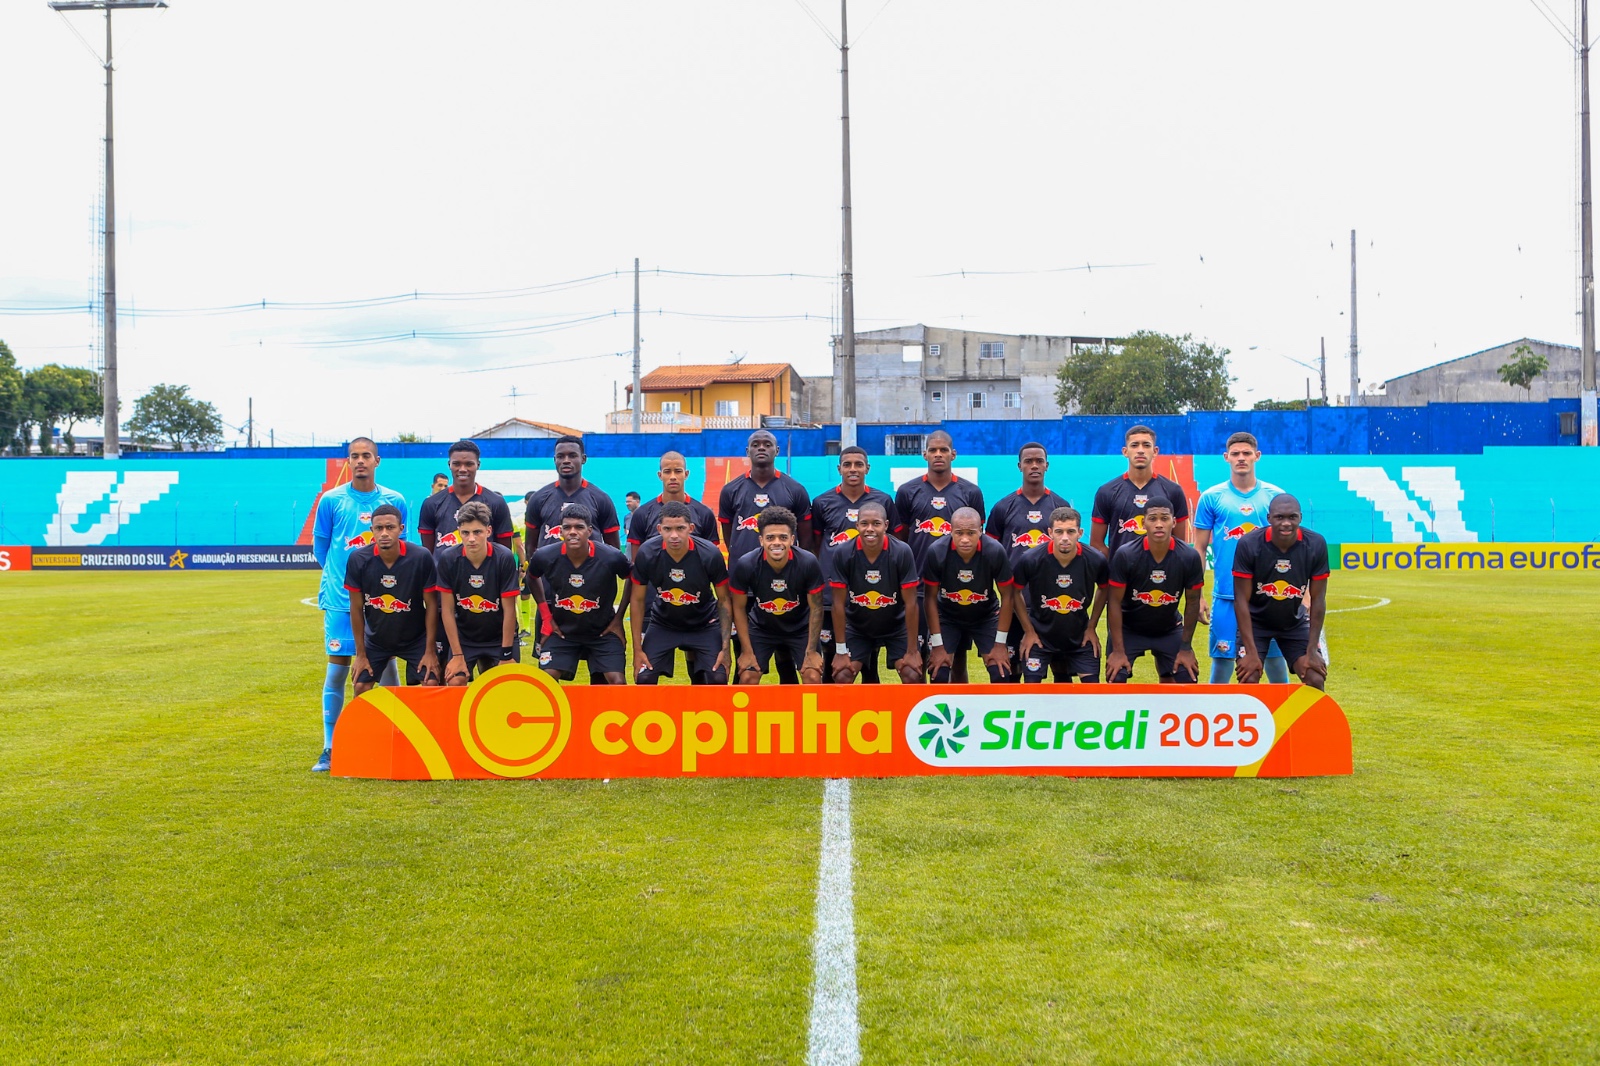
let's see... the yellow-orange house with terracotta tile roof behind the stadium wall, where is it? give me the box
[606,363,805,434]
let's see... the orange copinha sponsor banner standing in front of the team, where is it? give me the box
[333,664,1350,781]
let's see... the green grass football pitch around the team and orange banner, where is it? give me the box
[0,573,1600,1063]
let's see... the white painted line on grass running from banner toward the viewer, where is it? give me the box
[805,779,861,1066]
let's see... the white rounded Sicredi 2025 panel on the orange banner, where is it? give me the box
[906,693,1277,768]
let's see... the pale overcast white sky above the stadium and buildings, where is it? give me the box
[0,0,1578,443]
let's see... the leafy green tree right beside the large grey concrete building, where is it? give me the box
[1056,330,1234,415]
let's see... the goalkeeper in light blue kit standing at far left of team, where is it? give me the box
[310,437,405,773]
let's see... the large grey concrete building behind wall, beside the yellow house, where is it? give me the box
[800,325,1106,423]
